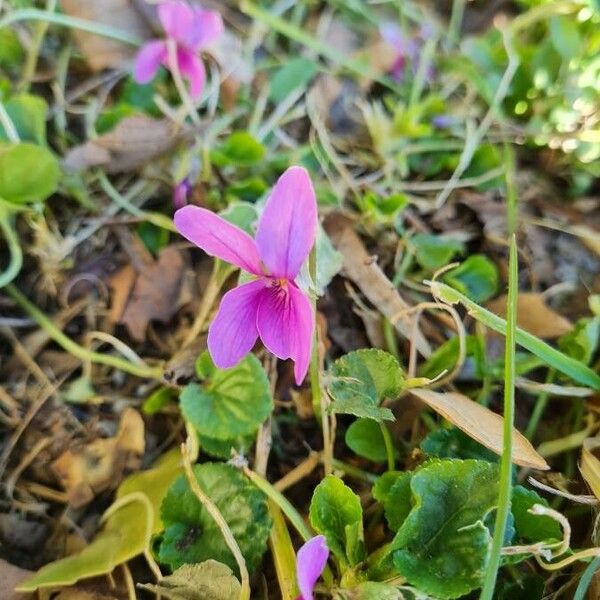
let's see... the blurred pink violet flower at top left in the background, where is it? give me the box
[133,0,223,100]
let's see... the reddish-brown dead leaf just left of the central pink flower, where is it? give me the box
[110,246,188,342]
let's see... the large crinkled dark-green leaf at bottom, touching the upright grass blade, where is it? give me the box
[392,460,498,598]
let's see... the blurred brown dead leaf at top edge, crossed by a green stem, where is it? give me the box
[60,0,152,71]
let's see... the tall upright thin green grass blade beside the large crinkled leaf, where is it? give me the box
[479,234,519,600]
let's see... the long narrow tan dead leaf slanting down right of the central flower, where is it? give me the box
[324,214,431,358]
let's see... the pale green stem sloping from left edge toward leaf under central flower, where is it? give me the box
[5,284,162,379]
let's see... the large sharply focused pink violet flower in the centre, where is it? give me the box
[174,167,318,385]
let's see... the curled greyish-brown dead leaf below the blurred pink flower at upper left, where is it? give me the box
[63,115,191,173]
